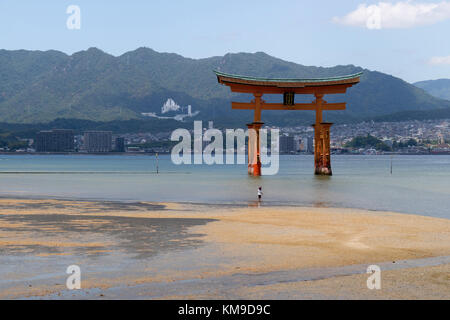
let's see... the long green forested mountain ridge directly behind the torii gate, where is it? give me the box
[0,48,450,125]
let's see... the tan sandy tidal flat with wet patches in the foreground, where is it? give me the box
[0,199,450,299]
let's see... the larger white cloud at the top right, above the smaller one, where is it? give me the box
[333,1,450,29]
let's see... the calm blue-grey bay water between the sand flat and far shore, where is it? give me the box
[0,155,450,218]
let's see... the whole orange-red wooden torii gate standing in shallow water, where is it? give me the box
[214,71,362,176]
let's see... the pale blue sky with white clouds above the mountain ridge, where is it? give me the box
[0,0,450,82]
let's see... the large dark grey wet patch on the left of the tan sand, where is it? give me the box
[0,209,215,259]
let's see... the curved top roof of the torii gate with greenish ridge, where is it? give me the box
[214,70,363,88]
